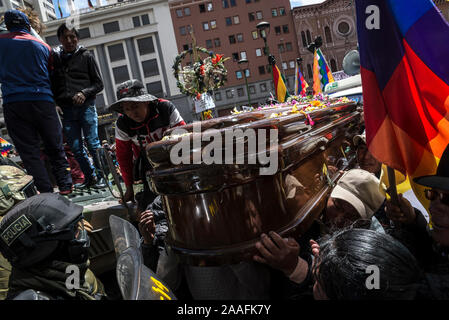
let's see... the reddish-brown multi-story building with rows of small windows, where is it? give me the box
[169,0,298,114]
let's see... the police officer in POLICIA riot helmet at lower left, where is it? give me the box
[0,194,105,300]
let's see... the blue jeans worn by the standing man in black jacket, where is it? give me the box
[61,100,101,181]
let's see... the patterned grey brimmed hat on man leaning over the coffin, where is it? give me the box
[109,79,157,113]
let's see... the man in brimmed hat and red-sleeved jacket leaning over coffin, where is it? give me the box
[109,79,185,205]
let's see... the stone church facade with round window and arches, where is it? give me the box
[292,0,449,86]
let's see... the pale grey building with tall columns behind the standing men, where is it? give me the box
[43,0,192,139]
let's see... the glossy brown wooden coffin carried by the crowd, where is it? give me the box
[147,102,360,265]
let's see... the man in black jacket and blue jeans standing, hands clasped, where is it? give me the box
[51,23,106,188]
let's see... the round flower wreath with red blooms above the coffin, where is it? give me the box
[172,47,229,99]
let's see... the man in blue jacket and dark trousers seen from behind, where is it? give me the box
[0,10,72,194]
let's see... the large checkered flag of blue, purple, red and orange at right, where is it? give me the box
[356,0,449,207]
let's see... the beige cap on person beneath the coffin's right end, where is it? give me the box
[330,169,385,219]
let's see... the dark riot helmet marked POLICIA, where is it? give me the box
[0,193,90,268]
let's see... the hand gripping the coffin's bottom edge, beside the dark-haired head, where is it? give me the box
[253,231,300,276]
